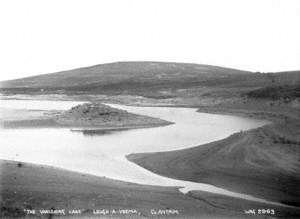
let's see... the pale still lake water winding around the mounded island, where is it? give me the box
[0,100,284,203]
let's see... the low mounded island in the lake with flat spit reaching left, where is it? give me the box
[0,103,173,130]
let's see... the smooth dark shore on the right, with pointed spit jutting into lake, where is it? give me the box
[127,101,300,215]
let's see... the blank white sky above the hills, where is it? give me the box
[0,0,300,80]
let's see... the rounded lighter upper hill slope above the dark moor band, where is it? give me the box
[1,62,248,88]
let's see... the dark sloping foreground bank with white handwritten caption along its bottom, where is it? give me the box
[0,160,297,218]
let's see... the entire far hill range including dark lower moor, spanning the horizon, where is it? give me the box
[0,62,300,98]
